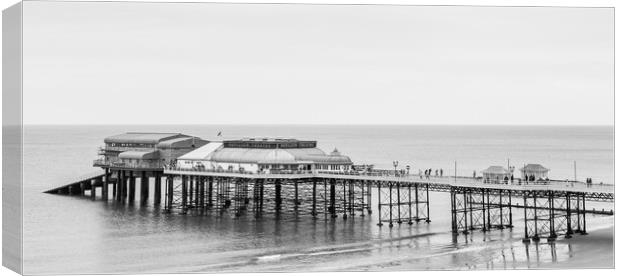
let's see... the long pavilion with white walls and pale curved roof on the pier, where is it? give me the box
[177,138,353,173]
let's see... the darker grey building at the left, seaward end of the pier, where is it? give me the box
[95,132,208,169]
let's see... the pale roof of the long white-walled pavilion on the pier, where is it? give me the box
[179,138,353,165]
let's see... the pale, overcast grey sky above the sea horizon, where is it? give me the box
[23,1,614,125]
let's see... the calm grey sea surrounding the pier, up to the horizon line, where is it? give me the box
[24,125,614,274]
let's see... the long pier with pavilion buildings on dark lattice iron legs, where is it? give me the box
[46,133,614,242]
